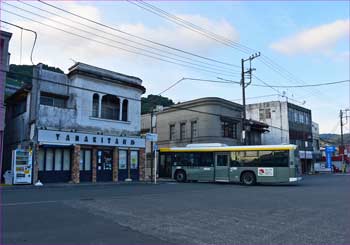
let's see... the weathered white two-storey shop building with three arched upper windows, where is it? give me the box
[6,63,145,183]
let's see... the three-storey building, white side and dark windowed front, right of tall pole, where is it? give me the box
[246,101,314,173]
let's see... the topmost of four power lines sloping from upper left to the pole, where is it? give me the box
[38,0,239,67]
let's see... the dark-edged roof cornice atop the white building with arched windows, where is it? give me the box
[68,62,146,93]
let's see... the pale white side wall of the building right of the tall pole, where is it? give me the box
[246,101,289,145]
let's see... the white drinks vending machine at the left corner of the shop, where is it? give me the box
[12,149,33,184]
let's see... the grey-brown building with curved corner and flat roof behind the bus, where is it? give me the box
[141,97,267,177]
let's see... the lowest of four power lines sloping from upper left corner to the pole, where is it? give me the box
[1,8,238,75]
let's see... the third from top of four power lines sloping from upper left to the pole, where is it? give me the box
[4,2,238,76]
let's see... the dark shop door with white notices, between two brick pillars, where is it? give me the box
[96,150,113,181]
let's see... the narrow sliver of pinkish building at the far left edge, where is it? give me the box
[0,31,12,179]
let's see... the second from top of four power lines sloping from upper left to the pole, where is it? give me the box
[13,0,241,74]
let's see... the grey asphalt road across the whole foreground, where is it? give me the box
[1,175,350,244]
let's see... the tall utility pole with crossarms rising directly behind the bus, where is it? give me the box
[241,52,260,145]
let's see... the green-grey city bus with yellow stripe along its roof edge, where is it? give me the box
[158,143,301,185]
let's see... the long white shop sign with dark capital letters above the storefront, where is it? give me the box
[38,130,145,148]
